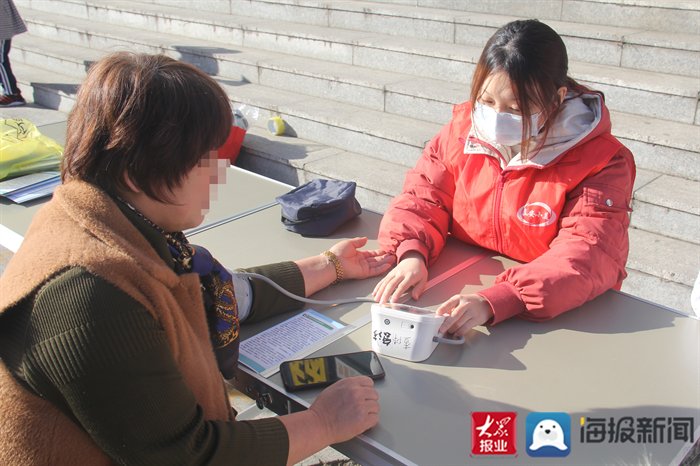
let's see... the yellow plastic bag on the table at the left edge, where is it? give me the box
[0,118,63,180]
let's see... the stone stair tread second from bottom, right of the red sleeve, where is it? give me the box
[635,175,700,217]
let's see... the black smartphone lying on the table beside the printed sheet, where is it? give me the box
[280,351,384,392]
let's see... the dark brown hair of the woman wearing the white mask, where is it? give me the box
[471,19,585,157]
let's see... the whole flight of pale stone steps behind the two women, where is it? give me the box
[12,0,700,310]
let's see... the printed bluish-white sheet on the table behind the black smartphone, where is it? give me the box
[239,309,346,377]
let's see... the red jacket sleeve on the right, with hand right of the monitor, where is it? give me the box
[479,148,635,323]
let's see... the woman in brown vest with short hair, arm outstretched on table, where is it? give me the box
[0,53,390,465]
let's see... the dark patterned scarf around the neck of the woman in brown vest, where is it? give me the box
[118,198,240,379]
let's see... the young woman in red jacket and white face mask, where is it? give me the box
[374,20,635,335]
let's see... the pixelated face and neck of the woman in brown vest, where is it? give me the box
[122,151,228,231]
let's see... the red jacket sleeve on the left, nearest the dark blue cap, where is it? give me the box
[379,124,455,264]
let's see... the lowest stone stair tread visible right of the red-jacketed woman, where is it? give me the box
[627,228,700,286]
